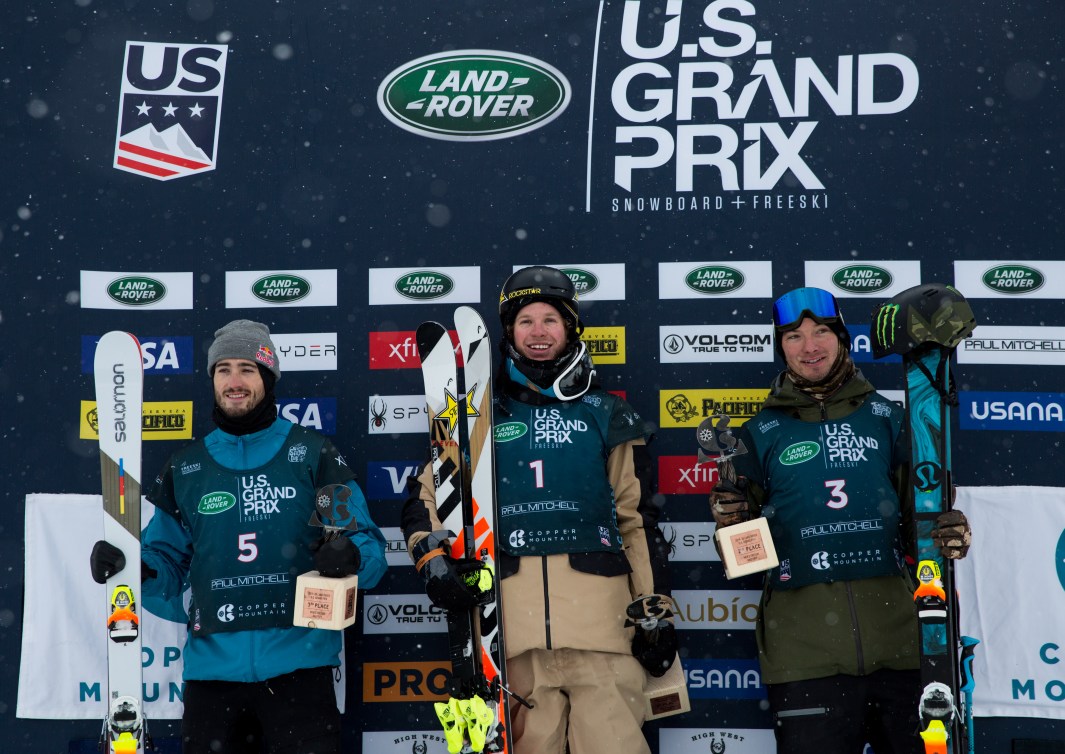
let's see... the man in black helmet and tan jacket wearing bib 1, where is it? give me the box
[403,266,677,754]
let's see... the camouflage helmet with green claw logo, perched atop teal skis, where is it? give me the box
[871,283,977,359]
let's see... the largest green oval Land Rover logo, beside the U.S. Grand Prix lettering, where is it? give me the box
[377,50,570,142]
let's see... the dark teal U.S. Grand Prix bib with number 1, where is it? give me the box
[494,391,644,556]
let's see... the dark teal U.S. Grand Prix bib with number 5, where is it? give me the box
[166,427,324,636]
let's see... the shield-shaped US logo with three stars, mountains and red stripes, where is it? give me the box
[113,42,227,181]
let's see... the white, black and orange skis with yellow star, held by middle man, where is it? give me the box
[416,307,513,754]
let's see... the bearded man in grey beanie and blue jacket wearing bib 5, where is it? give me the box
[89,319,387,754]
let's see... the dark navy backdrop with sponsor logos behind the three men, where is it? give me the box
[0,0,1065,754]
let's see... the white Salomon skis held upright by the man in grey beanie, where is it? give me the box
[94,331,151,754]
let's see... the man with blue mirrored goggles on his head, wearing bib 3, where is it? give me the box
[710,288,970,754]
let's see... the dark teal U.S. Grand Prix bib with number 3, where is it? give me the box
[747,394,902,589]
